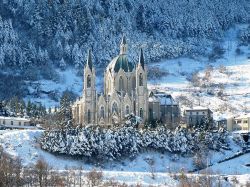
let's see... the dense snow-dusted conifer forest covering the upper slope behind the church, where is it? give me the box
[0,0,250,66]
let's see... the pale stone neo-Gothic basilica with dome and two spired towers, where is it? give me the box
[72,36,179,125]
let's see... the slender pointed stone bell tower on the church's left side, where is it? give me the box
[83,50,96,124]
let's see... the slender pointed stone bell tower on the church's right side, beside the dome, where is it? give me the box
[136,49,148,122]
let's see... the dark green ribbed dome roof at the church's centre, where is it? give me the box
[108,54,134,73]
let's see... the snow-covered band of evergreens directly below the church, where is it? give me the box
[41,120,229,160]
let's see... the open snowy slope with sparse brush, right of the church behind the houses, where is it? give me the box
[149,25,250,118]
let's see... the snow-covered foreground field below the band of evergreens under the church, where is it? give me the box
[0,130,250,186]
